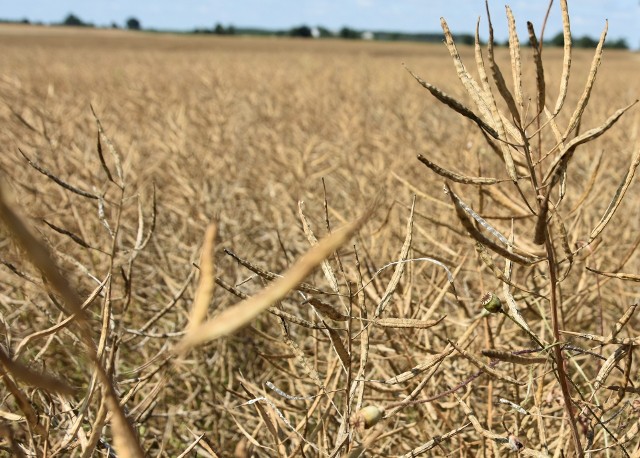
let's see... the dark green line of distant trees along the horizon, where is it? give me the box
[0,13,629,49]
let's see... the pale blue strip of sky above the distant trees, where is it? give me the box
[5,0,640,49]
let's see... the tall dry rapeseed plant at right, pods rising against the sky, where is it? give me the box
[410,0,640,456]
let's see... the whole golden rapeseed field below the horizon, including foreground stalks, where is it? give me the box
[0,11,640,457]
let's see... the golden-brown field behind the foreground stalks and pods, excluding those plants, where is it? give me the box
[0,24,640,456]
